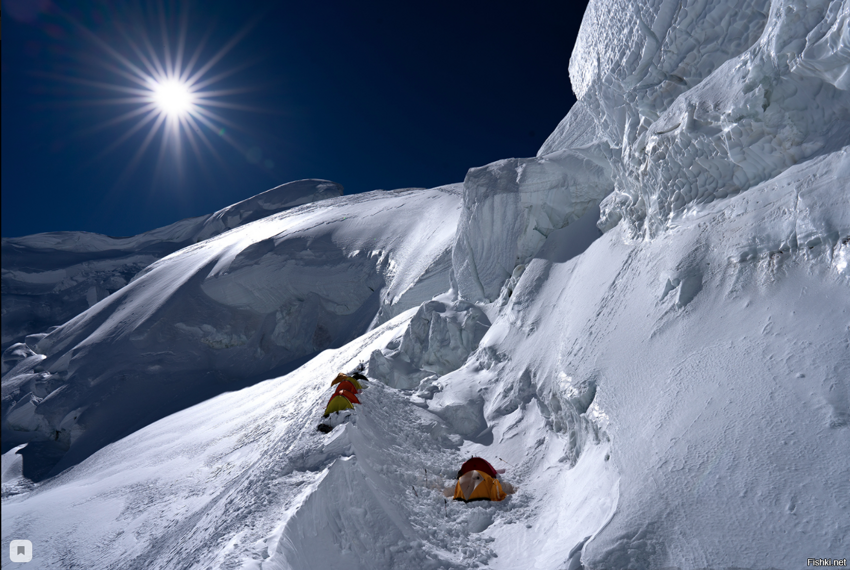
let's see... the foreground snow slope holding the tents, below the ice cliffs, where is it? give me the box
[3,151,850,569]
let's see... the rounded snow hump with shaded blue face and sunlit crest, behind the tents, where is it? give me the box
[3,187,460,478]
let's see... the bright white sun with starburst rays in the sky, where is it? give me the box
[44,2,262,193]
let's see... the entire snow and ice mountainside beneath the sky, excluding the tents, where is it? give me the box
[2,0,850,570]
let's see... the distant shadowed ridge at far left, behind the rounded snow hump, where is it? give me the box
[0,180,342,350]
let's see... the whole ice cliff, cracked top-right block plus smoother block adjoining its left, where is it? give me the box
[453,0,850,300]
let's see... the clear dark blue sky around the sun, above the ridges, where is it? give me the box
[1,0,584,237]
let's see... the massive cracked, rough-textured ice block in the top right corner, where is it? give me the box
[570,1,850,236]
